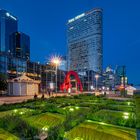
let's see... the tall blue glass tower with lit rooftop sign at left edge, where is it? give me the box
[0,9,18,73]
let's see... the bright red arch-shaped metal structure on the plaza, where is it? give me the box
[60,71,83,92]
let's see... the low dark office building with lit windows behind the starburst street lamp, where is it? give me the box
[26,61,66,92]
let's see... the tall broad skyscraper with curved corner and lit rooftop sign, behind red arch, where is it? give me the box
[67,8,103,73]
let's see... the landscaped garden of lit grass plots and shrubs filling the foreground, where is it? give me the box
[0,94,140,140]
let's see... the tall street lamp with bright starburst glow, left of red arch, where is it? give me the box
[51,56,61,93]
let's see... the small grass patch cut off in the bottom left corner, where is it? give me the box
[0,128,19,140]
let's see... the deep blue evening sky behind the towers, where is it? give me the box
[0,0,140,84]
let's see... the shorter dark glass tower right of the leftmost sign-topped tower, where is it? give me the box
[8,32,30,78]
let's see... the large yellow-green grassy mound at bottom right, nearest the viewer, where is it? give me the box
[65,122,136,140]
